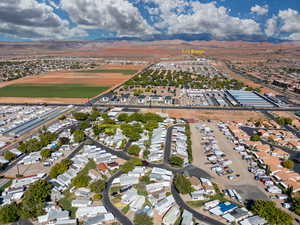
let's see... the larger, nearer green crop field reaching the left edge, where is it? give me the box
[0,84,109,98]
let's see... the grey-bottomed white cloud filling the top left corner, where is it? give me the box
[0,0,87,39]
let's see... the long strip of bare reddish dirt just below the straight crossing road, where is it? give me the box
[143,109,265,121]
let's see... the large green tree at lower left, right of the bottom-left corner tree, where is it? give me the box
[21,180,52,218]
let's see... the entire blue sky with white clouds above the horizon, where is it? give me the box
[0,0,300,41]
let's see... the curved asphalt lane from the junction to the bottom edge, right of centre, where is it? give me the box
[171,183,224,225]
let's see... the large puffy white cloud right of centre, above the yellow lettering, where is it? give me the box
[148,0,261,39]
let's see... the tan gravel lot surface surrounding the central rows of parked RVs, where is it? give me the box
[191,122,267,200]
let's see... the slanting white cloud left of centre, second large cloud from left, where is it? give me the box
[60,0,155,36]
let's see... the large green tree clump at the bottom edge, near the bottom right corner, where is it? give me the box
[252,200,293,225]
